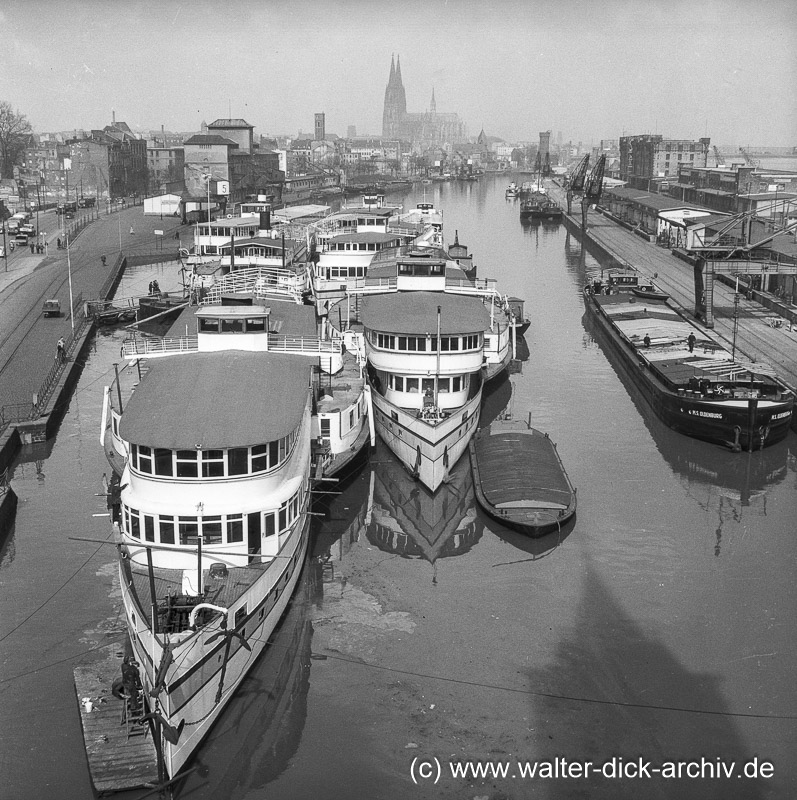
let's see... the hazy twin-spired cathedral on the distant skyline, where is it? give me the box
[382,57,467,150]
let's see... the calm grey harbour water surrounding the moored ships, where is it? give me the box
[0,176,797,800]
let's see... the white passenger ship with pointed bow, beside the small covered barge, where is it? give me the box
[330,248,511,491]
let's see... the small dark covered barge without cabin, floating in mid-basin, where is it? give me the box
[469,412,576,536]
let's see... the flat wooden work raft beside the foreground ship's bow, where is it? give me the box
[74,645,158,795]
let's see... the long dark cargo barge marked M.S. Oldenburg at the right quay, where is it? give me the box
[584,276,794,452]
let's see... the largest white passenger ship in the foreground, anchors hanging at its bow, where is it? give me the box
[102,296,368,778]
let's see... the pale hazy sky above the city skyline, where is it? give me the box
[0,0,797,146]
